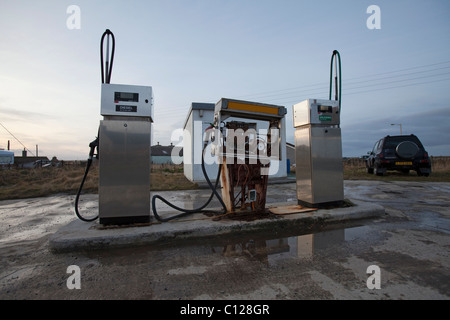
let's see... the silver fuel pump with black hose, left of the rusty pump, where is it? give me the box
[75,30,153,224]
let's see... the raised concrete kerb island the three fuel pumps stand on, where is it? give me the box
[49,199,385,253]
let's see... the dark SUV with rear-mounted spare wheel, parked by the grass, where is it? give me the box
[366,134,431,177]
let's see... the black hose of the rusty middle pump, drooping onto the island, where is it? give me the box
[152,144,227,222]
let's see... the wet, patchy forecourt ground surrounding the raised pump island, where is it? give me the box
[0,181,450,300]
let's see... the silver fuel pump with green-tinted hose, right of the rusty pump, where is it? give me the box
[293,50,344,207]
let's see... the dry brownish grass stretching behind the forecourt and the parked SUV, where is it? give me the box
[0,157,450,200]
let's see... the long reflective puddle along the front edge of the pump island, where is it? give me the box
[87,225,372,268]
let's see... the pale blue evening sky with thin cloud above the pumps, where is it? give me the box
[0,0,450,160]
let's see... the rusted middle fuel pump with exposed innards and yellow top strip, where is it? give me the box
[211,98,286,213]
